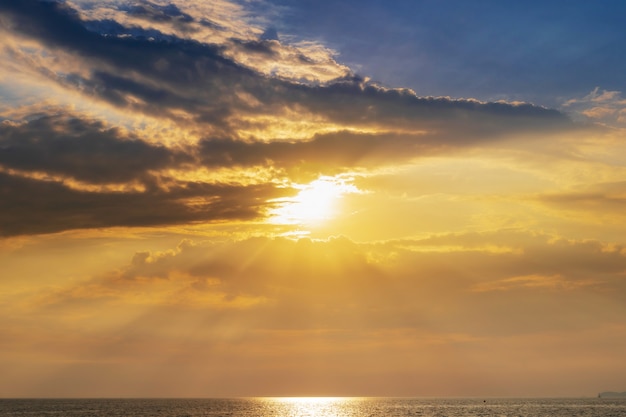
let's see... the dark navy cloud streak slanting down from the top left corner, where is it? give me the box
[0,0,245,84]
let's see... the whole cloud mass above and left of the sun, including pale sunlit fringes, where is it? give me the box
[0,0,579,239]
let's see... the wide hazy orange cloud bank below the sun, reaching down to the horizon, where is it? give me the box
[0,231,626,395]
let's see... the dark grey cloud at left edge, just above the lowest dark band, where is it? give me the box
[0,114,191,184]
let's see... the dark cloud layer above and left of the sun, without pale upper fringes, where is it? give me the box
[0,0,574,235]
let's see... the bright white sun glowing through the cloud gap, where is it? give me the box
[271,177,359,226]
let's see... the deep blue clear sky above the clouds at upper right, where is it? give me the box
[260,0,626,106]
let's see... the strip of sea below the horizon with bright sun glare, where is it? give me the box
[0,398,626,417]
